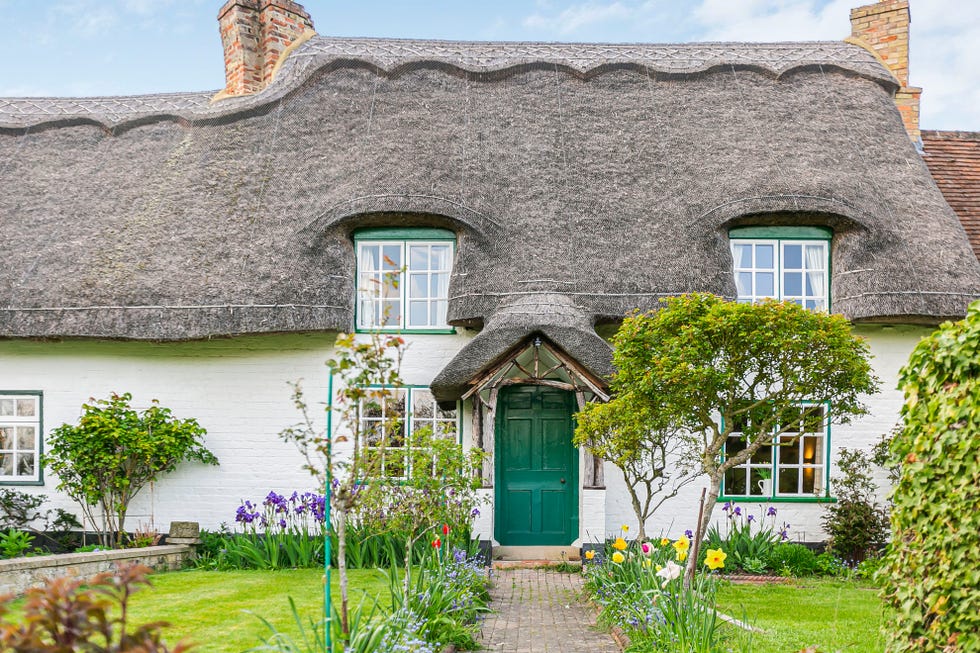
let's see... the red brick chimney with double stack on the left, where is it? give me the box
[215,0,314,99]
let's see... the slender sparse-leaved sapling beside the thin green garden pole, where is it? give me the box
[279,332,405,639]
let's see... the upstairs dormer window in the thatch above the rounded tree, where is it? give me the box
[728,227,833,311]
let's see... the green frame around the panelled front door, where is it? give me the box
[493,383,582,546]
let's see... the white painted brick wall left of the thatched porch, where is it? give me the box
[0,334,470,532]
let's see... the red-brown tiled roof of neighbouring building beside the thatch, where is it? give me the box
[922,130,980,259]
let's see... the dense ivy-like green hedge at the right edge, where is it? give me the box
[879,301,980,653]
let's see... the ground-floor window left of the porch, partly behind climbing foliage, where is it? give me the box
[360,386,460,478]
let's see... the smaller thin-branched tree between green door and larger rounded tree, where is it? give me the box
[574,402,697,540]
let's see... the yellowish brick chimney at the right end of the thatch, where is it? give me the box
[846,0,922,147]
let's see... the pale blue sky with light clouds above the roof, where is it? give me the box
[0,0,980,131]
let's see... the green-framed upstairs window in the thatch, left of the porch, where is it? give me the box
[354,228,456,331]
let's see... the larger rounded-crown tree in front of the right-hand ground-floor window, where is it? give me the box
[613,294,878,580]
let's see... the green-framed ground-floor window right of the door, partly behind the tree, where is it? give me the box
[722,402,830,500]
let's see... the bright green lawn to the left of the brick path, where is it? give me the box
[130,569,391,653]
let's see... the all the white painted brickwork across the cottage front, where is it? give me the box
[0,326,930,541]
